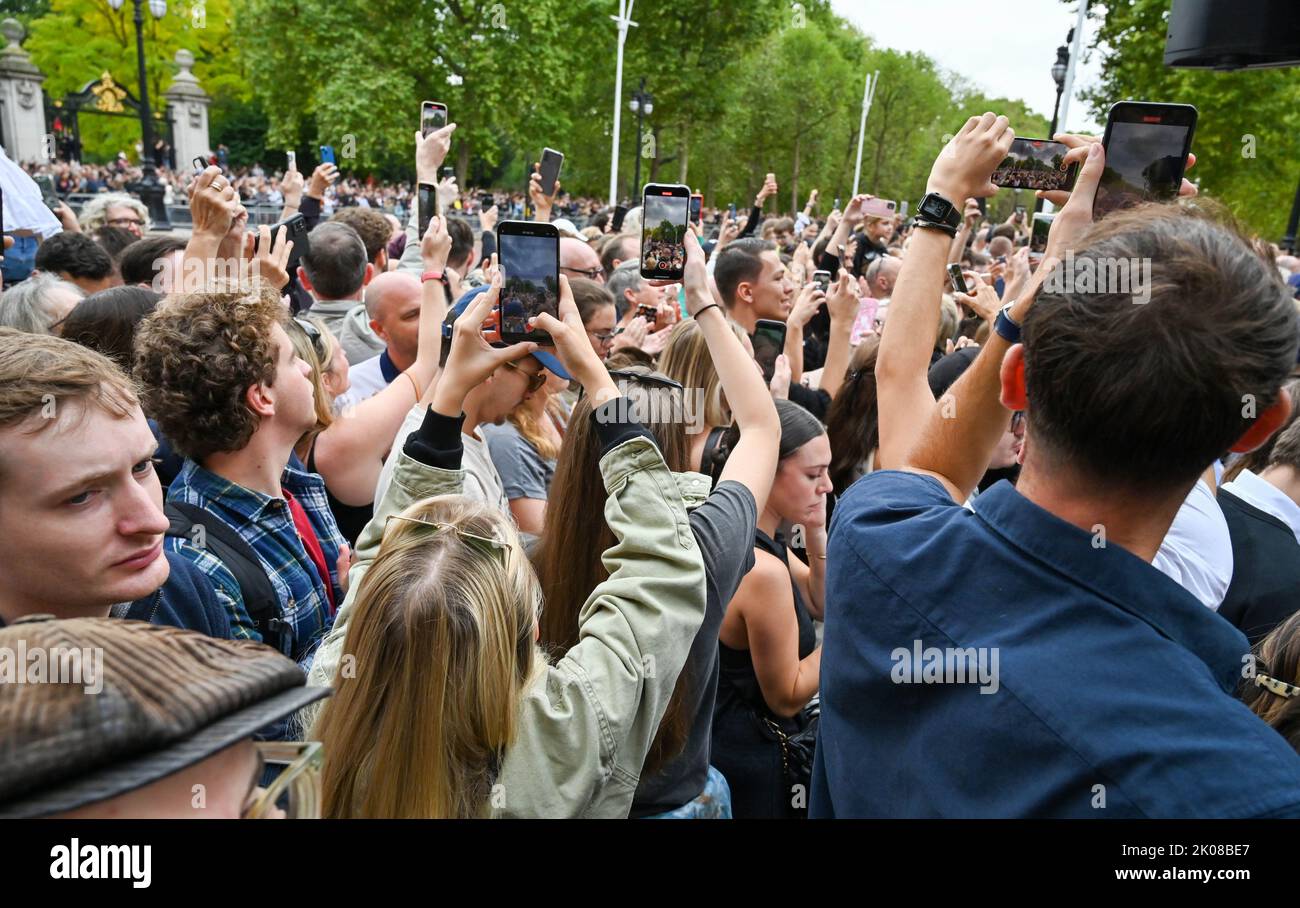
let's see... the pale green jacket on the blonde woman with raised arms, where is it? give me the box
[308,438,705,817]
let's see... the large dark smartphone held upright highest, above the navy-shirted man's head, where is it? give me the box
[1092,101,1196,219]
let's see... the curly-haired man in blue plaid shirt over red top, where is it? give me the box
[137,279,348,669]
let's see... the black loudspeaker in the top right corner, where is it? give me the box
[1165,0,1300,69]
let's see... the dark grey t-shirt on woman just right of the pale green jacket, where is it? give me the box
[629,480,758,817]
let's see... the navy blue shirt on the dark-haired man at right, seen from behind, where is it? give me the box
[810,471,1300,817]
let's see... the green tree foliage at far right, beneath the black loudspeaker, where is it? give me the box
[1084,0,1300,239]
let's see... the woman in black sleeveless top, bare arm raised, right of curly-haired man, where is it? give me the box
[280,217,451,546]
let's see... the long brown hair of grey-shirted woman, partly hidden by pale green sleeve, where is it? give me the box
[533,367,692,775]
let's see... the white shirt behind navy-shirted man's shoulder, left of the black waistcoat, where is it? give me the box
[1152,479,1232,611]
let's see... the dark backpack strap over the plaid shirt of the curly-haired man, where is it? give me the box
[164,501,294,656]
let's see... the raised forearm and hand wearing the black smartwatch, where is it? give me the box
[876,113,1015,470]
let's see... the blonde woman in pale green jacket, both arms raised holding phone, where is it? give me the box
[309,276,705,818]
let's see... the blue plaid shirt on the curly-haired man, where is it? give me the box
[166,459,346,670]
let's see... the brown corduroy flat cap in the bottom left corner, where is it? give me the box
[0,615,332,817]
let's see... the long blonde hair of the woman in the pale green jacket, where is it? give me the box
[309,496,545,818]
